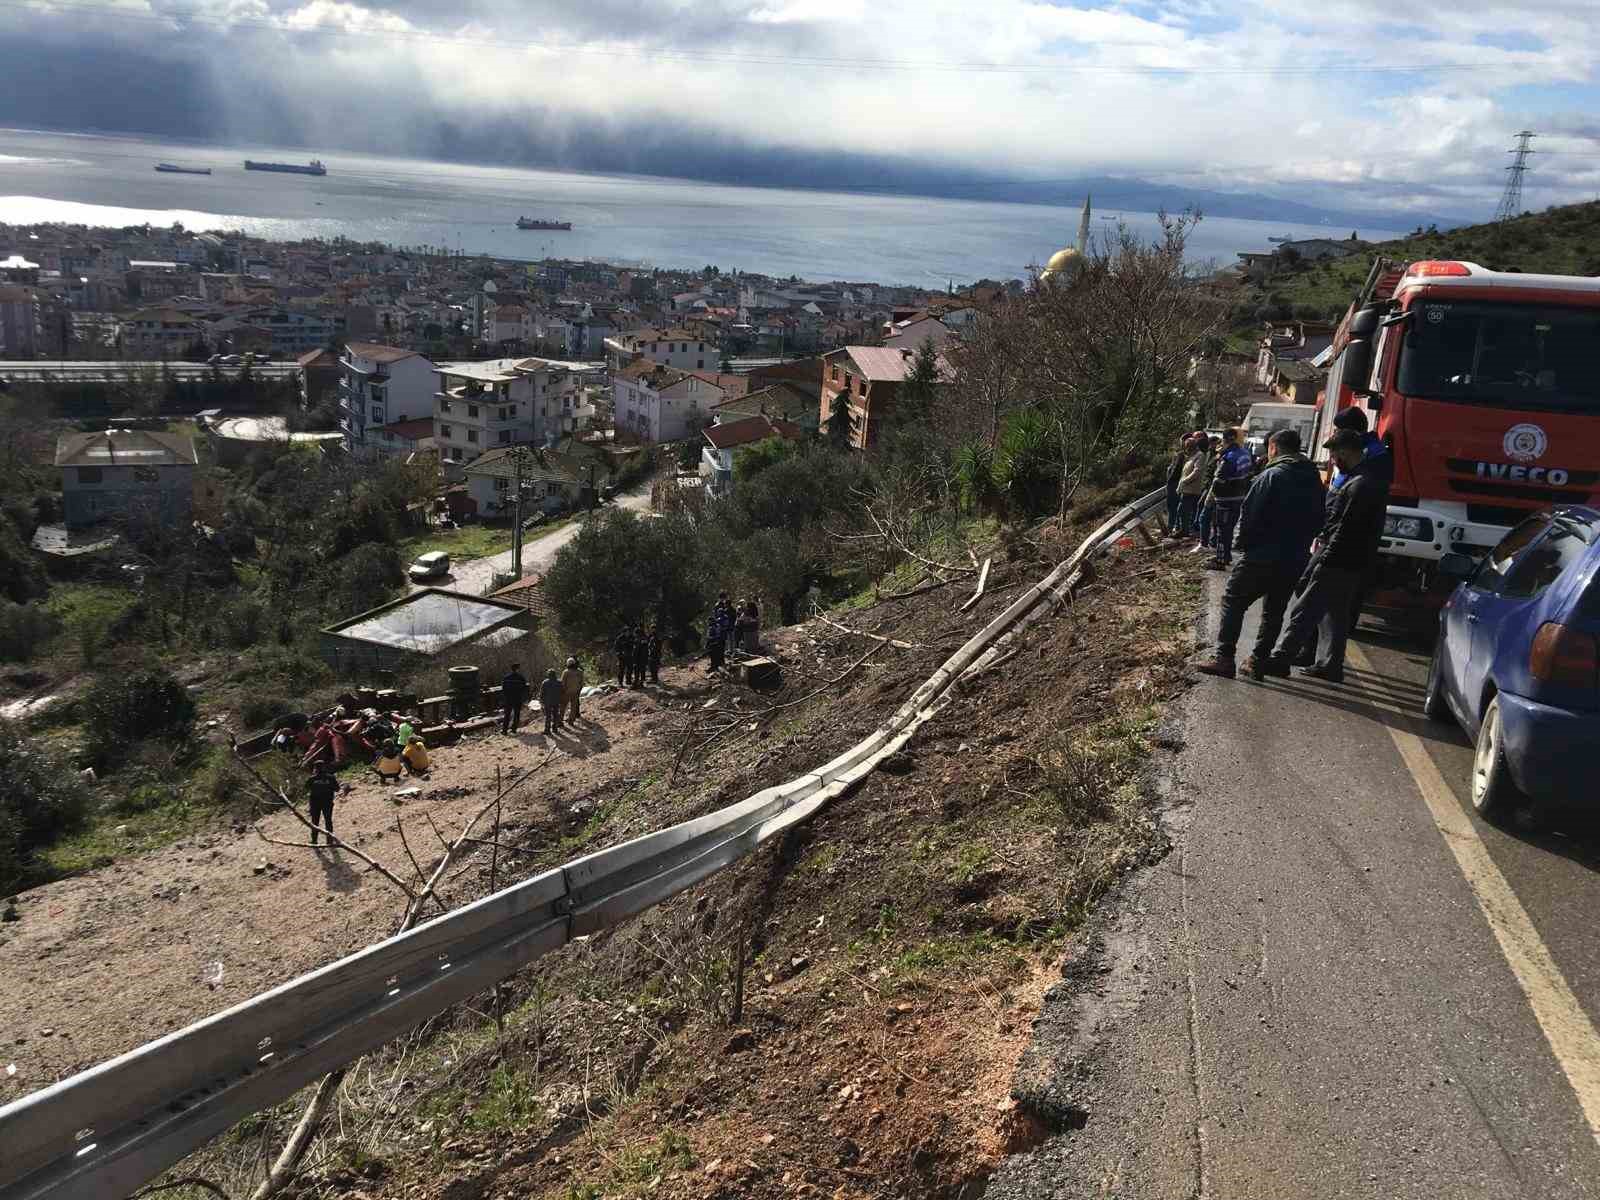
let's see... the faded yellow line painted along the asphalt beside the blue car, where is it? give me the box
[1347,642,1600,1142]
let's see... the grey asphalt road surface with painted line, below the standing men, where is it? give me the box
[987,578,1600,1200]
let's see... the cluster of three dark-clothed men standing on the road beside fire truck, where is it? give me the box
[1198,408,1394,683]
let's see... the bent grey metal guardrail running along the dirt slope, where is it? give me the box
[0,491,1165,1200]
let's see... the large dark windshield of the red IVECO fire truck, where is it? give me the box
[1400,299,1600,413]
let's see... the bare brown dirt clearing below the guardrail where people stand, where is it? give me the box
[0,669,693,1101]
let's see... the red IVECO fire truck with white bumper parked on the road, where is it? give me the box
[1315,258,1600,622]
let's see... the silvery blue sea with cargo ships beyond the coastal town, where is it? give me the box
[0,130,1398,288]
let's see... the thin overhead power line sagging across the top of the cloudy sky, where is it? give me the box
[0,0,1561,78]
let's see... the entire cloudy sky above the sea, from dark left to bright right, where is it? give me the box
[0,0,1600,218]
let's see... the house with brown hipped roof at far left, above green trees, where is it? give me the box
[56,429,197,530]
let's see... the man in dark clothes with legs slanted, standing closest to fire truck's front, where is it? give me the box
[1266,429,1389,683]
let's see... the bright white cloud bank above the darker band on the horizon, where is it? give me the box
[0,0,1600,211]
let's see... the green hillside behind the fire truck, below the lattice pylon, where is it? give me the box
[1240,202,1600,323]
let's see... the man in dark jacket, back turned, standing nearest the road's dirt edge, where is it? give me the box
[1198,429,1323,680]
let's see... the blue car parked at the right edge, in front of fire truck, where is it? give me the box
[1422,507,1600,819]
